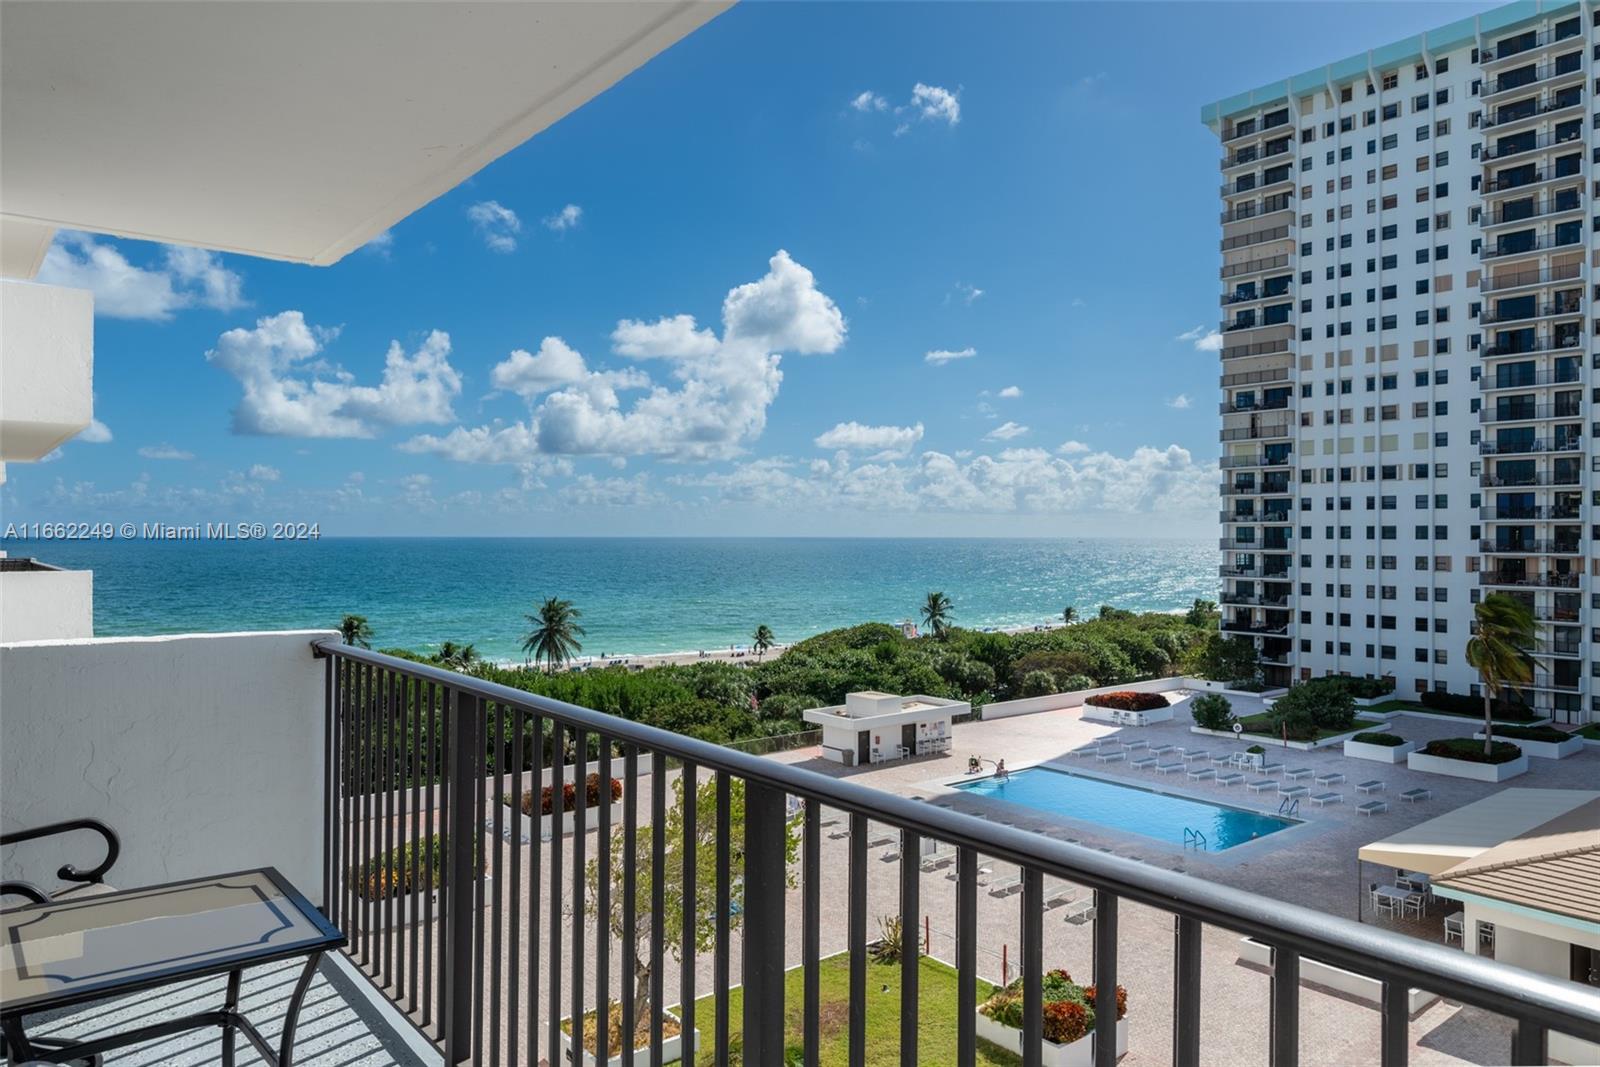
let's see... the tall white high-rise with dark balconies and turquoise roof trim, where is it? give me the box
[1202,2,1600,723]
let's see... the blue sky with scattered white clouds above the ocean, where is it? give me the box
[0,3,1488,536]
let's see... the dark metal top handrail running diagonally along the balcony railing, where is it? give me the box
[312,638,1600,1041]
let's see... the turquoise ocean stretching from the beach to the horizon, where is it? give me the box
[0,537,1218,659]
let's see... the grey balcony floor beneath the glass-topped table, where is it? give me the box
[17,958,443,1067]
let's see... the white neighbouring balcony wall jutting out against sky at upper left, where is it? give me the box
[0,282,94,462]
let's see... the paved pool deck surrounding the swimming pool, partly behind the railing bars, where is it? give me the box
[773,697,1600,1067]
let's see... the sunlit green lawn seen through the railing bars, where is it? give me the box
[681,955,1022,1067]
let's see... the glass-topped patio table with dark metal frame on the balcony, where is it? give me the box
[0,867,346,1067]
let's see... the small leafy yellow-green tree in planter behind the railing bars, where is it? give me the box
[560,776,800,1067]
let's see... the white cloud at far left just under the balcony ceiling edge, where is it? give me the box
[38,232,245,322]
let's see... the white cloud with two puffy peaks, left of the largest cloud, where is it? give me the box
[206,310,461,437]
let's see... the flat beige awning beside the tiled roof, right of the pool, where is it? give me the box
[1360,789,1600,875]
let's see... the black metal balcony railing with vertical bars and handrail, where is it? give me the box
[312,643,1600,1067]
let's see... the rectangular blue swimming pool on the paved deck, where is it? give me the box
[955,766,1296,853]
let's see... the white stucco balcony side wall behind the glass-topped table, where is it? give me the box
[0,630,336,901]
